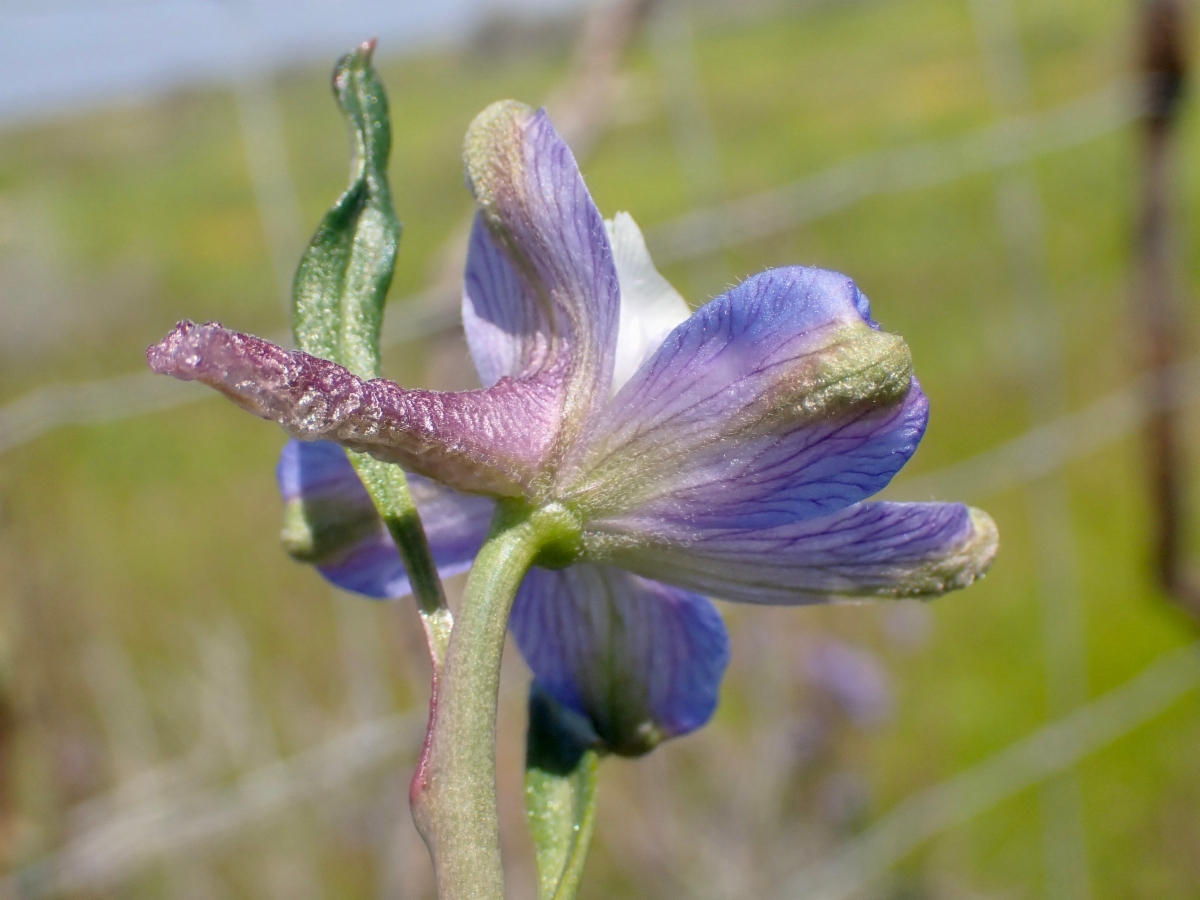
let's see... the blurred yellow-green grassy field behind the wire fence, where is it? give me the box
[0,0,1200,900]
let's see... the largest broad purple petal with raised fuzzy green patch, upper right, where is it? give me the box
[562,268,928,534]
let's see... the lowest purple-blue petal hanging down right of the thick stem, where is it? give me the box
[509,564,730,756]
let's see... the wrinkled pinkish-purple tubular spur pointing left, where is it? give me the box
[146,322,562,496]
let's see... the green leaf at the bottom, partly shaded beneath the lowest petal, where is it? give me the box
[524,685,600,900]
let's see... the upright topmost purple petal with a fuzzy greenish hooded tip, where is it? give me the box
[463,101,620,458]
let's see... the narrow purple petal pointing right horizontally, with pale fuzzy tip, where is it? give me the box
[600,503,998,604]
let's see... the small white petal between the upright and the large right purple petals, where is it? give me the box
[605,212,691,394]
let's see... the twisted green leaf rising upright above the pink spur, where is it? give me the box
[292,42,400,378]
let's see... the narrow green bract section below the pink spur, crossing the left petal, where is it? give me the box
[347,452,454,667]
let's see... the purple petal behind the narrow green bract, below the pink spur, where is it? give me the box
[276,440,493,599]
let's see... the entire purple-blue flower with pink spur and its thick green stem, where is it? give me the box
[148,47,997,896]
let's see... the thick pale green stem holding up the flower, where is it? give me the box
[410,502,556,900]
